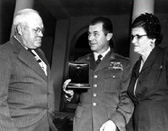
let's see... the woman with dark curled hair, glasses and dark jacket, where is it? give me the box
[128,13,168,131]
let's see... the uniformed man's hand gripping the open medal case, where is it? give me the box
[63,79,74,101]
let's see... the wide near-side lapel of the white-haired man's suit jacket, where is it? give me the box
[11,38,47,80]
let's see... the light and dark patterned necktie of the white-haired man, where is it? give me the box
[28,49,47,75]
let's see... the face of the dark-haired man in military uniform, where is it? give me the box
[88,23,112,54]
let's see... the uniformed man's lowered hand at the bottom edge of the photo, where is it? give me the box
[100,120,117,131]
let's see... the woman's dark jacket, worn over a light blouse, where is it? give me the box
[128,46,168,131]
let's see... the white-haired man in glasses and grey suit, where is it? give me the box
[0,9,57,131]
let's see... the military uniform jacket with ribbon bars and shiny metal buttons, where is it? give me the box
[73,51,133,131]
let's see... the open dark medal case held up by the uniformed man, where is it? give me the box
[67,62,90,89]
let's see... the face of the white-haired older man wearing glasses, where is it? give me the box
[19,15,43,49]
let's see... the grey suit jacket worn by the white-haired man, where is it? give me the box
[0,37,56,131]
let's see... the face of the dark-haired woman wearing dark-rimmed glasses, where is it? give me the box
[131,27,153,55]
